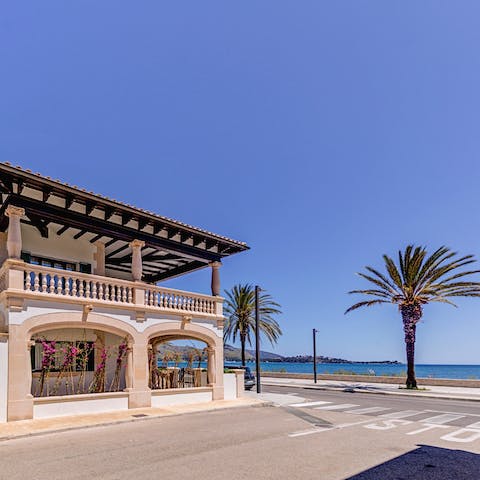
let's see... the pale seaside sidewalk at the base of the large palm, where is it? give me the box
[261,377,480,402]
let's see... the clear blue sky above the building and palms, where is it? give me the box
[0,0,480,363]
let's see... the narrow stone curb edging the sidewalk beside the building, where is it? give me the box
[0,400,273,442]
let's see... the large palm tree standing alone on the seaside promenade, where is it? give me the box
[345,245,480,388]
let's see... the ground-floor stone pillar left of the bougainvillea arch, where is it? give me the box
[7,325,33,421]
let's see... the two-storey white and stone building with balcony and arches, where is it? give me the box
[0,163,248,422]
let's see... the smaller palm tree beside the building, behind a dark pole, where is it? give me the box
[223,284,282,366]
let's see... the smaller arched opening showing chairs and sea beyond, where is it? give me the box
[148,335,213,390]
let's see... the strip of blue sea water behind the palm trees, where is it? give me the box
[225,362,480,380]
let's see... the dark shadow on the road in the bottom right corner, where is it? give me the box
[347,445,480,480]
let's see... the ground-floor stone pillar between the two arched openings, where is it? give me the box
[128,343,152,408]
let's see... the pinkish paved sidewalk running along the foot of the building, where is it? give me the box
[0,397,267,441]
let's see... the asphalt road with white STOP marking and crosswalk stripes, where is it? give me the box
[0,387,480,480]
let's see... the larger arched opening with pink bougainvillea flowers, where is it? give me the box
[30,325,128,397]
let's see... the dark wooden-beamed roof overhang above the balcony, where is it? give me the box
[0,163,249,283]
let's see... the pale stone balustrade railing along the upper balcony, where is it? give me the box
[0,260,222,317]
